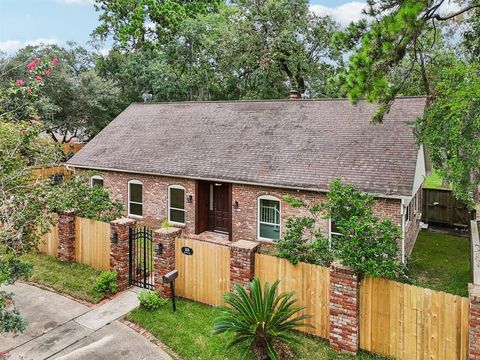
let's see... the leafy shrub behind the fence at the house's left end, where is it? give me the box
[52,172,124,222]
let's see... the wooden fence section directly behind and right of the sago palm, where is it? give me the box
[255,254,330,338]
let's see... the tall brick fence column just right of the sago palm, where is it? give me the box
[329,261,360,354]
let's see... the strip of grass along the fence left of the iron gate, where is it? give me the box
[23,253,104,304]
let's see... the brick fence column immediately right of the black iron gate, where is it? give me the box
[153,227,182,298]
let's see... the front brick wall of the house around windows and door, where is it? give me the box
[89,172,402,251]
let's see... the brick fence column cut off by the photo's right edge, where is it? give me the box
[468,284,480,360]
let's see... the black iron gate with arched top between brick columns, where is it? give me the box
[128,226,155,290]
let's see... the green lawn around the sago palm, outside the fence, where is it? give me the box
[127,299,382,360]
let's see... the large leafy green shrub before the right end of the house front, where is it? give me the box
[277,180,408,281]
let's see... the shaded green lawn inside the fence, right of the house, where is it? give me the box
[409,230,471,296]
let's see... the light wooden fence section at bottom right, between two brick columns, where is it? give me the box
[360,278,469,360]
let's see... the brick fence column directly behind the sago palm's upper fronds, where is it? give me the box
[230,240,258,291]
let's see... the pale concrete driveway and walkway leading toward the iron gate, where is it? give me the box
[0,283,171,360]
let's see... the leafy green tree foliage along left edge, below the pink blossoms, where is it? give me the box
[0,119,60,332]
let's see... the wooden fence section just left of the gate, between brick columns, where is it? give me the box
[75,216,110,270]
